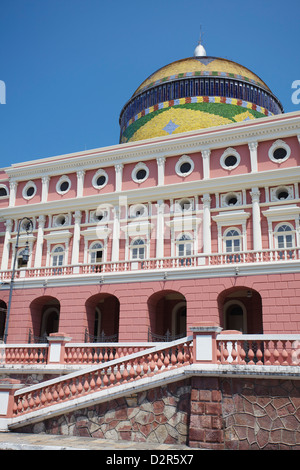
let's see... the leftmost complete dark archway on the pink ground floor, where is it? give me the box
[29,296,60,342]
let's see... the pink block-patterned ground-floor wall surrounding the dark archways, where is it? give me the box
[0,273,300,343]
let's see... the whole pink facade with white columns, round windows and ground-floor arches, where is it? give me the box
[0,113,300,343]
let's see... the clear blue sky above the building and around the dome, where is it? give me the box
[0,0,300,167]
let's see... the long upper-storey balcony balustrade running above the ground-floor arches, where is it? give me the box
[0,247,300,284]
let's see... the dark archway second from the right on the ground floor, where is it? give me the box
[148,290,187,341]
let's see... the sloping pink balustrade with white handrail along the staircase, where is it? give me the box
[13,338,193,417]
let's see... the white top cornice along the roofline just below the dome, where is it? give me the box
[5,111,300,181]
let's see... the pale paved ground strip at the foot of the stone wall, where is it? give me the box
[0,432,195,453]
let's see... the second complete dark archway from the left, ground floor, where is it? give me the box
[85,294,120,343]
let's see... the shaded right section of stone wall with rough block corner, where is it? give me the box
[189,378,300,450]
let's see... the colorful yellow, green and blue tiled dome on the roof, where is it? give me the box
[120,46,283,143]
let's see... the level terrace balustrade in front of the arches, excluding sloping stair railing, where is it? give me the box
[0,331,300,367]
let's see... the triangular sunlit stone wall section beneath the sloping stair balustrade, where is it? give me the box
[18,381,191,444]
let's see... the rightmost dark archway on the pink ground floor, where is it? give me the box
[218,287,263,334]
